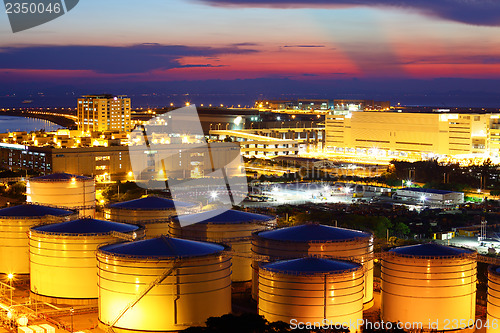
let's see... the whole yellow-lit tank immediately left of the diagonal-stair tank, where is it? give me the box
[29,219,144,304]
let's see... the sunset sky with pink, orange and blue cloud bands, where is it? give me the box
[0,0,500,105]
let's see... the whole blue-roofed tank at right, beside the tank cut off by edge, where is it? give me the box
[381,243,477,331]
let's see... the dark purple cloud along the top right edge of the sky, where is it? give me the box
[199,0,500,26]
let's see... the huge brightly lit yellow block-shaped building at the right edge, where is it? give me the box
[325,110,500,159]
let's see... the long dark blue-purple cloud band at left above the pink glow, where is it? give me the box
[0,43,257,74]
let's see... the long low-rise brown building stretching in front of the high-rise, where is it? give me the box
[0,142,240,180]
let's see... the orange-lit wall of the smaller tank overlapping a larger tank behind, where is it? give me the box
[258,268,364,332]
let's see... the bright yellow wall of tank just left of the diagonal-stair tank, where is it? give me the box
[29,230,137,299]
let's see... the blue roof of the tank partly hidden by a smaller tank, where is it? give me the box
[258,223,372,242]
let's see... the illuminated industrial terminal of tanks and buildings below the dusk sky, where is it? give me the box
[0,95,500,333]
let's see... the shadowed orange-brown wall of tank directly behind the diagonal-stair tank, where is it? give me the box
[170,220,276,282]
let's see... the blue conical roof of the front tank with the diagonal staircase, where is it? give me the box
[99,236,224,259]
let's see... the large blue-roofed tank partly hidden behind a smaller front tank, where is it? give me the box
[252,223,373,308]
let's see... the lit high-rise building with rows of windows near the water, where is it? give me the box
[78,94,132,132]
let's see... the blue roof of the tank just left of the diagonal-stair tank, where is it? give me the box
[32,219,139,234]
